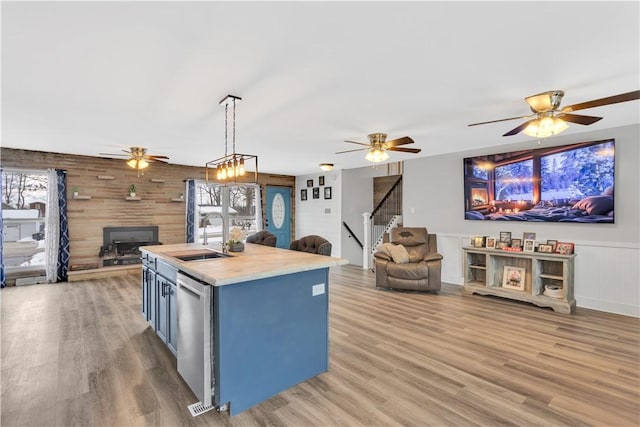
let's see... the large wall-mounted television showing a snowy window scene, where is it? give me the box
[464,139,615,224]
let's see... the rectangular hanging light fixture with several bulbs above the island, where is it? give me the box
[205,95,258,183]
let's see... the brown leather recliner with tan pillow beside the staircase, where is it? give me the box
[374,227,442,292]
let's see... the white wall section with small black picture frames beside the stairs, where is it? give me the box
[295,170,342,257]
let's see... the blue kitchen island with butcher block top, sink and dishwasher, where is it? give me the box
[141,244,347,415]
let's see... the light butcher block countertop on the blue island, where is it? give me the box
[140,243,349,286]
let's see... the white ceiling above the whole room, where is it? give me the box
[1,1,640,175]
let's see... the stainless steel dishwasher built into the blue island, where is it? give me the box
[177,273,214,407]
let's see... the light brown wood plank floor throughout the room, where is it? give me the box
[0,266,640,427]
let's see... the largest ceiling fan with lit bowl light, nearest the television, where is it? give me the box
[468,90,640,138]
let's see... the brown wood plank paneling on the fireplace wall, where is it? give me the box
[0,147,296,265]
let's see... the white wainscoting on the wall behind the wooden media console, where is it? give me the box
[437,233,640,317]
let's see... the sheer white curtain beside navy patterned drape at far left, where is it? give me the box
[44,169,60,283]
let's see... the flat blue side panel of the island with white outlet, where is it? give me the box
[213,268,329,415]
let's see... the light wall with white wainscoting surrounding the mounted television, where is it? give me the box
[403,125,640,317]
